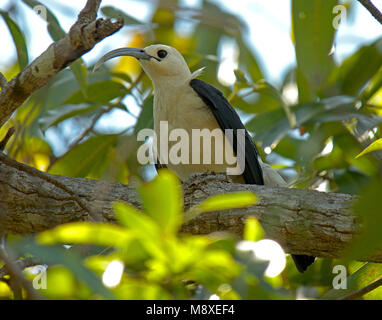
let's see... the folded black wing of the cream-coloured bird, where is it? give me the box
[190,79,264,185]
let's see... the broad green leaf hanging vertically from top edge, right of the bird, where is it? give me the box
[292,0,338,102]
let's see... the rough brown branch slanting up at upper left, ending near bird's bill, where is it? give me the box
[0,0,123,127]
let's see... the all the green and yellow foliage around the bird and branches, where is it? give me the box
[0,0,382,299]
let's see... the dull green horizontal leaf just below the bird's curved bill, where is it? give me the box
[64,81,128,104]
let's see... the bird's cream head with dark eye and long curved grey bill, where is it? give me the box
[94,44,191,86]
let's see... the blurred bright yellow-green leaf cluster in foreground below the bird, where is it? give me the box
[3,169,290,299]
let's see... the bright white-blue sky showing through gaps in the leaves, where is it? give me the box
[0,0,382,154]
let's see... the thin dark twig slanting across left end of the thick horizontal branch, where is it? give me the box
[0,152,101,221]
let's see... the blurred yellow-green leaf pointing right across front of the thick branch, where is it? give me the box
[184,192,257,222]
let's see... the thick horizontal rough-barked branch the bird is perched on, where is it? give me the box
[0,154,382,262]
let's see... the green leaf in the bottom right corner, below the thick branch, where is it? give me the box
[320,262,382,300]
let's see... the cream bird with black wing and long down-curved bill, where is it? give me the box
[94,44,315,273]
